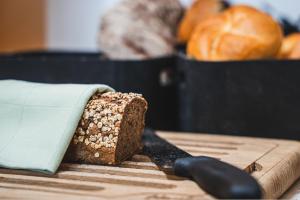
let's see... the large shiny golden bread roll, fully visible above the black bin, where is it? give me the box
[187,5,283,61]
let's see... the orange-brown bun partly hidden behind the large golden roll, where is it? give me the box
[177,0,225,43]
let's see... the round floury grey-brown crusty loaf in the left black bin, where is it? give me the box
[98,0,183,59]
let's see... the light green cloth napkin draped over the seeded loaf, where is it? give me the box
[0,80,113,173]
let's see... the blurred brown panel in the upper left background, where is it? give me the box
[0,0,47,52]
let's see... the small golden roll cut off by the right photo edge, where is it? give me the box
[278,33,300,59]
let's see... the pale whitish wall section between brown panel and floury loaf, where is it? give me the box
[46,0,118,50]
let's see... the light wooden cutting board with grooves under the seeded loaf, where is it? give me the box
[0,132,300,200]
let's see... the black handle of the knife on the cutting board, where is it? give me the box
[174,156,262,199]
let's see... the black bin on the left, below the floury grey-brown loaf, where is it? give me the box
[0,52,179,130]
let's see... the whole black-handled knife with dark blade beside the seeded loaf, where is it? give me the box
[142,129,262,199]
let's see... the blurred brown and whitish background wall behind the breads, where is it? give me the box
[0,0,300,52]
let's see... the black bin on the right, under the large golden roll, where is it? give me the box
[177,54,300,139]
